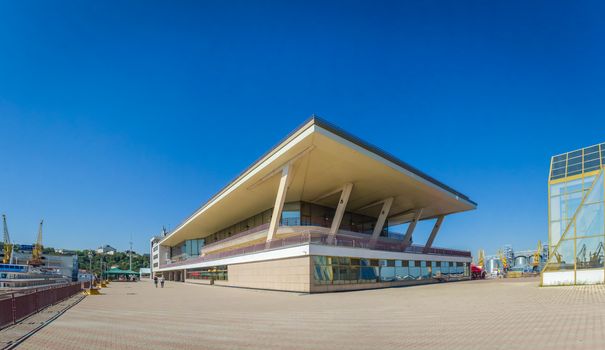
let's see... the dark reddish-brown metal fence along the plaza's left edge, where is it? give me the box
[0,282,82,329]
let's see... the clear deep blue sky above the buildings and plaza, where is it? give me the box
[0,1,605,252]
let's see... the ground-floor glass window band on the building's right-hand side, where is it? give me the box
[313,256,470,285]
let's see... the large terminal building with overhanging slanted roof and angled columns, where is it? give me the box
[150,117,477,293]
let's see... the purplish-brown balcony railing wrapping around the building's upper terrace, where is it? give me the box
[160,230,471,268]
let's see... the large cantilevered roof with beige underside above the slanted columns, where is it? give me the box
[160,116,477,245]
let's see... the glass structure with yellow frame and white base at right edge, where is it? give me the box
[542,143,605,286]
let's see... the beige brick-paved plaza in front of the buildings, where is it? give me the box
[13,278,605,350]
